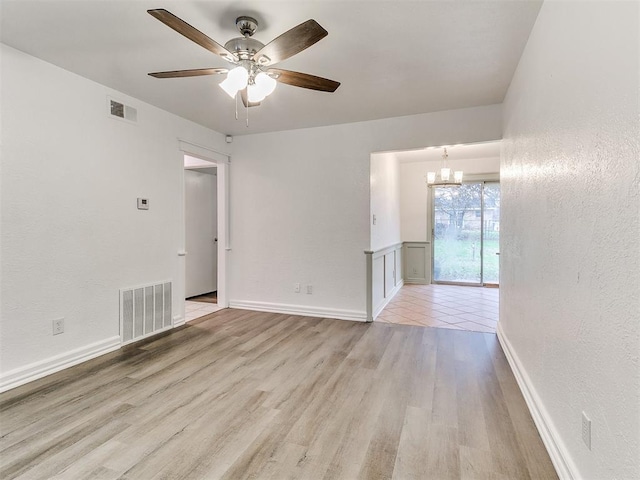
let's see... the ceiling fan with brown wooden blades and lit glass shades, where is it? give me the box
[147,8,340,107]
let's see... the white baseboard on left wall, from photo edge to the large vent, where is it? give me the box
[0,336,120,392]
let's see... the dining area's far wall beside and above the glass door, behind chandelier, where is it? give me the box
[400,157,500,242]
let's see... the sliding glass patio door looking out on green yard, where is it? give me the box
[432,181,500,286]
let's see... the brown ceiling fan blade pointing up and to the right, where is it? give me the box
[253,20,328,66]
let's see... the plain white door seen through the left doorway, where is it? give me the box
[184,168,218,298]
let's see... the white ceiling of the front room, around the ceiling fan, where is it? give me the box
[0,0,542,135]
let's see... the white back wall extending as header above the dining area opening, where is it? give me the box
[229,105,502,318]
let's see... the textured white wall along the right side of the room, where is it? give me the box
[500,2,640,480]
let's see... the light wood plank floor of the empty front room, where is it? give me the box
[0,310,557,480]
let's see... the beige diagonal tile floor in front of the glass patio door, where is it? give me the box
[376,285,499,333]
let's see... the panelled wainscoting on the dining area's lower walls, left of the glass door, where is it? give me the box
[364,242,431,322]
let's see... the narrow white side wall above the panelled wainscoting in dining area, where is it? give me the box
[369,153,401,250]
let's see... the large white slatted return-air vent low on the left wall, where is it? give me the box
[120,282,173,344]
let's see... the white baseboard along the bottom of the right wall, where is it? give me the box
[497,323,580,480]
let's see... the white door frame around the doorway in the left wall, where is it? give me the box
[173,139,231,326]
